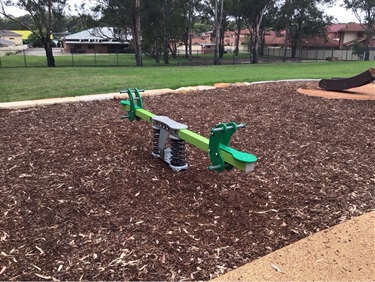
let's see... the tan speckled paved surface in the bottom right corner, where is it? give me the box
[211,211,375,282]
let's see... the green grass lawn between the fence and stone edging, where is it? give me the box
[0,60,375,102]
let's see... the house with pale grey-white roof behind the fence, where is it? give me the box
[63,27,131,54]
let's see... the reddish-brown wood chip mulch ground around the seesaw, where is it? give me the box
[0,82,375,280]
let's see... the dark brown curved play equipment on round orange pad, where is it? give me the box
[319,68,375,91]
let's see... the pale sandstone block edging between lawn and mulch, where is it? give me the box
[0,79,319,110]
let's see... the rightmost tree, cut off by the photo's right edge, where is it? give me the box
[344,0,375,61]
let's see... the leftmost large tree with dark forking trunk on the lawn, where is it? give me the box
[0,0,67,67]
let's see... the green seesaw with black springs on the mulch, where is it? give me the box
[120,89,257,172]
